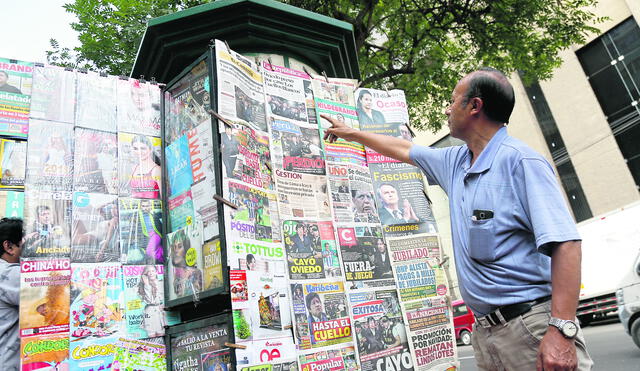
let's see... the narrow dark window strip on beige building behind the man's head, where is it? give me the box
[523,74,593,222]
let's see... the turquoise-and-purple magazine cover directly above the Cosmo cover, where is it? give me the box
[118,197,164,265]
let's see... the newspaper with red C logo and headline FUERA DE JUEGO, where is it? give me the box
[338,225,395,290]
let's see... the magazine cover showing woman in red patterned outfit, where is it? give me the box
[118,133,162,198]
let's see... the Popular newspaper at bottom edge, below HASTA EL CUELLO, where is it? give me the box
[298,345,360,371]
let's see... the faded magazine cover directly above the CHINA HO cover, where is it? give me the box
[22,189,72,258]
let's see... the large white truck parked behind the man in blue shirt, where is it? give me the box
[576,202,640,326]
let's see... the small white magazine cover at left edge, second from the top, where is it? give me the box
[0,139,27,188]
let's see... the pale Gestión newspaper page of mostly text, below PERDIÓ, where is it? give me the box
[275,169,331,220]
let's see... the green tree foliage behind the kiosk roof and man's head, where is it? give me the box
[48,0,602,129]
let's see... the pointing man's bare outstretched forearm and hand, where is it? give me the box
[320,114,415,165]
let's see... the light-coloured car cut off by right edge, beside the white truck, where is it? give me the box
[616,251,640,348]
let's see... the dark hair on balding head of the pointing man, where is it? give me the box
[464,67,516,123]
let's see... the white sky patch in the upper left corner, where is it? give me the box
[0,0,80,63]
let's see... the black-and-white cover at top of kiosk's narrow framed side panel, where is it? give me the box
[164,61,211,144]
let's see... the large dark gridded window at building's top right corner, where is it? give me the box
[576,17,640,189]
